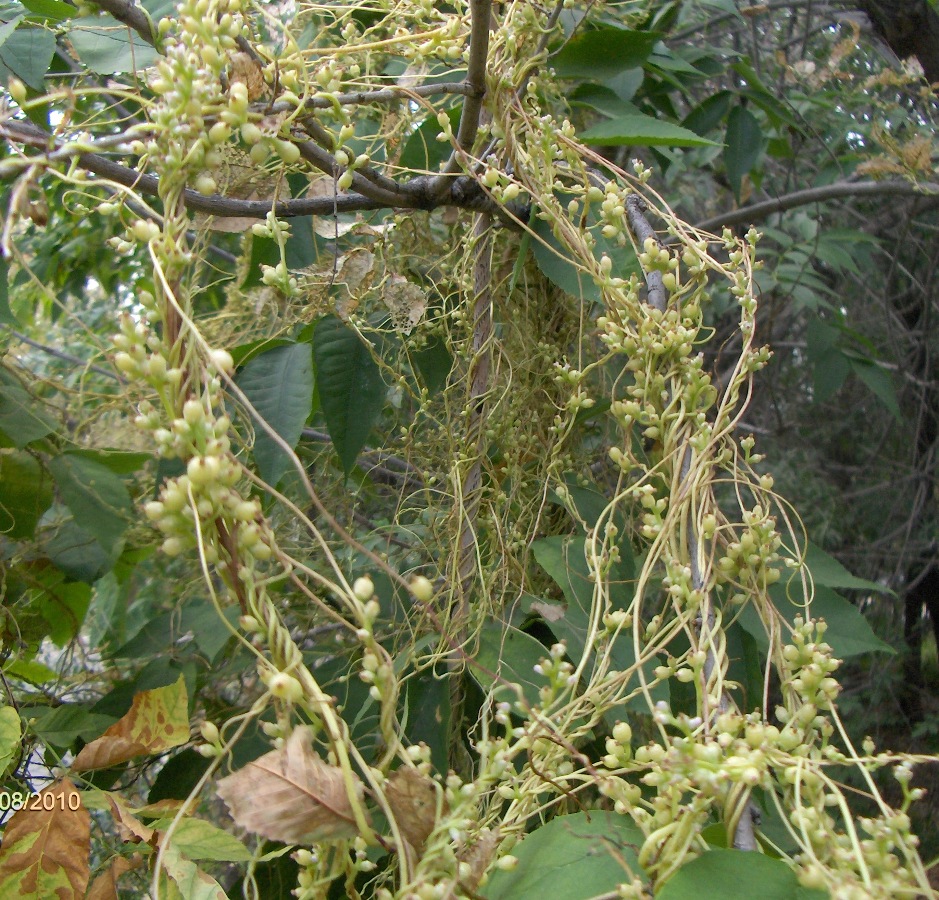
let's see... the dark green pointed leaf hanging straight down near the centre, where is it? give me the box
[313,316,387,475]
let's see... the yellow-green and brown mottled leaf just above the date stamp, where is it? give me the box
[72,676,189,772]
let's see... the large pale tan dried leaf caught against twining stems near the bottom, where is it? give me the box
[218,728,362,844]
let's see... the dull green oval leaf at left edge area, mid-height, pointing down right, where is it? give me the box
[49,453,131,556]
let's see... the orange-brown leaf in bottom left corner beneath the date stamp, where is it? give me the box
[0,778,91,900]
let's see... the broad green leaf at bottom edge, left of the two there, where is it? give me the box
[481,810,648,900]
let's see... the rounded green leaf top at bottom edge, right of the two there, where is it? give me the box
[655,850,828,900]
